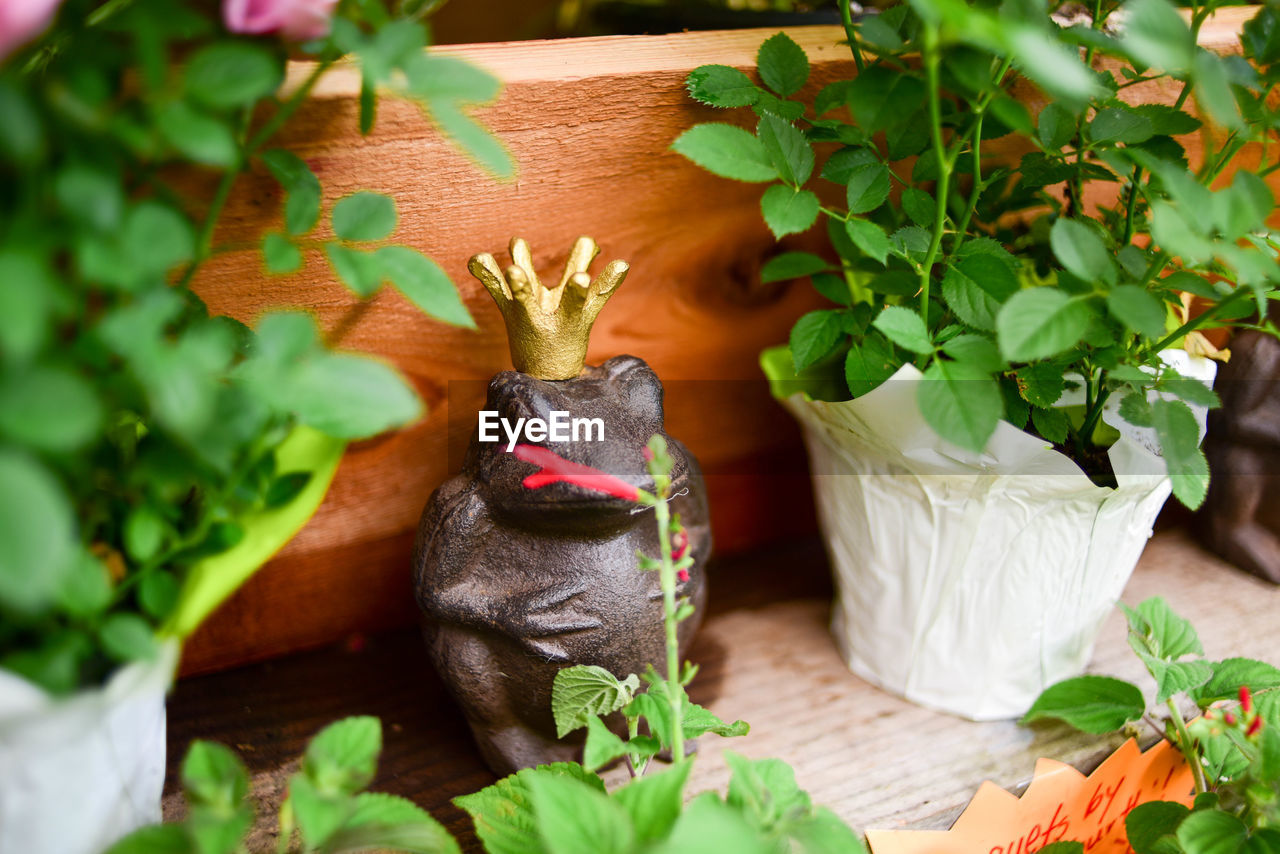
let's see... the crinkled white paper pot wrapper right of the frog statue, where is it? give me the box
[786,351,1216,721]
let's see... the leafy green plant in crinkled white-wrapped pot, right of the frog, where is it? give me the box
[673,0,1280,718]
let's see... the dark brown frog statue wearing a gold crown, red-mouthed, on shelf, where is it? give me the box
[413,238,710,775]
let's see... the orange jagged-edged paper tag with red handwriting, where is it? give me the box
[867,739,1194,854]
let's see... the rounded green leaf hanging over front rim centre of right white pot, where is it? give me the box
[916,360,1005,452]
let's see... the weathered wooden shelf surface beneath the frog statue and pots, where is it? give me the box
[165,530,1280,850]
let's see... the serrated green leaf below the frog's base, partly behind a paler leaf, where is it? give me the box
[453,762,604,854]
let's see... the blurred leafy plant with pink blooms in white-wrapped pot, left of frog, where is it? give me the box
[0,0,511,854]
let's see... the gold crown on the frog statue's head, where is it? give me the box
[467,237,630,379]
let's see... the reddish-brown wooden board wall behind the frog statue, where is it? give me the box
[183,6,1256,673]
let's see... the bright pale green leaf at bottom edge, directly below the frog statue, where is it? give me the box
[527,775,635,854]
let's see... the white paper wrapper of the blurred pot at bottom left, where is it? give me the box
[0,641,178,854]
